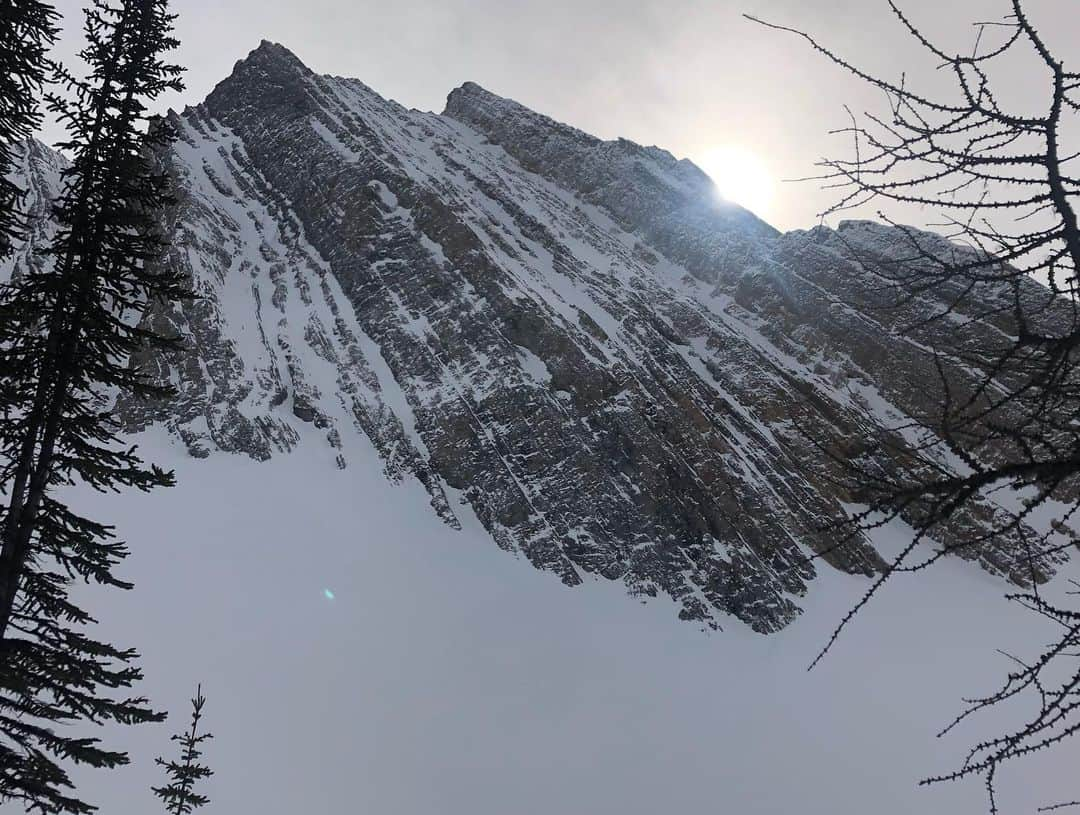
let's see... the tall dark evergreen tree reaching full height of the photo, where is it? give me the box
[0,0,185,813]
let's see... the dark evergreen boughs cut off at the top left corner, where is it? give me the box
[0,0,57,258]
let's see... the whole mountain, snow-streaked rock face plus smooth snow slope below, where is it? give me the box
[6,42,1077,815]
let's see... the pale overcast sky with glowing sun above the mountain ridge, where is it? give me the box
[44,0,1080,229]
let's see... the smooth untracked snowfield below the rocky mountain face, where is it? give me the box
[69,434,1080,815]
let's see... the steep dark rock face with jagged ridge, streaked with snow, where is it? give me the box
[2,42,1062,631]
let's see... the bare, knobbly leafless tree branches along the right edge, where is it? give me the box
[746,0,1080,812]
